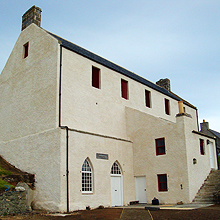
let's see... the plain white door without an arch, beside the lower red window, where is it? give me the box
[135,176,147,203]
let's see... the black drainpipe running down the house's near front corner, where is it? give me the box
[58,44,69,212]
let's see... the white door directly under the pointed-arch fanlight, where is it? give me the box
[111,176,122,206]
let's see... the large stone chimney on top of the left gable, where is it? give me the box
[22,5,41,31]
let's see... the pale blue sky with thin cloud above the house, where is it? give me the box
[0,0,220,132]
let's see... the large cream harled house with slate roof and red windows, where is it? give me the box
[0,6,217,211]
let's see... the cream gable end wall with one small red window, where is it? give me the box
[0,24,63,211]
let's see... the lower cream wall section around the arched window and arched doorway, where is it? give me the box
[65,131,135,210]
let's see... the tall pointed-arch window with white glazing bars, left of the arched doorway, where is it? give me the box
[82,159,92,192]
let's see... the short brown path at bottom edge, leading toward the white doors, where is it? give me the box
[120,208,152,220]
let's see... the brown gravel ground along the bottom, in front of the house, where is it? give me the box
[0,205,220,220]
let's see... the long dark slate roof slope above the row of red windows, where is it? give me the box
[47,31,196,109]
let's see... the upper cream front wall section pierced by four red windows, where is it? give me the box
[62,48,182,139]
